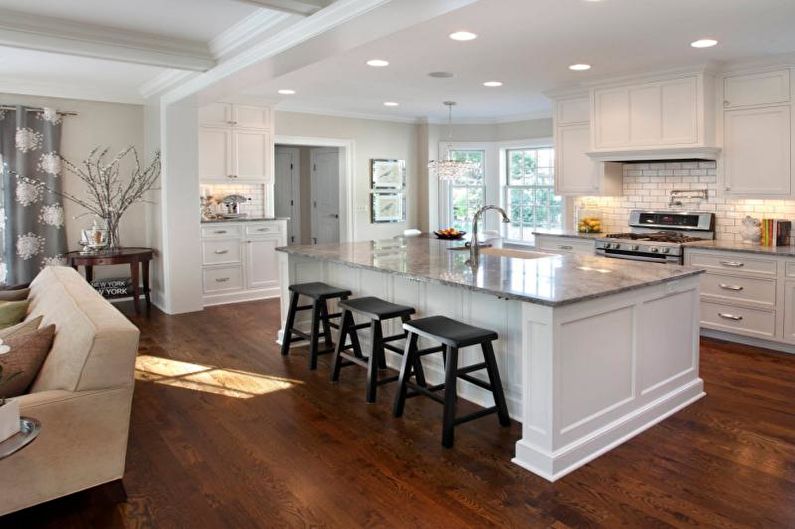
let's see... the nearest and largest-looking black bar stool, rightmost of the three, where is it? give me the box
[394,316,511,448]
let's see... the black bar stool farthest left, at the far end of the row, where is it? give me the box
[282,283,351,369]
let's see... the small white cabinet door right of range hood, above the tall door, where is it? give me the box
[723,69,790,108]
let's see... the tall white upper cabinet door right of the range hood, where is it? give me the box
[723,104,792,198]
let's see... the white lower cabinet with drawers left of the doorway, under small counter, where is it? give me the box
[202,220,287,306]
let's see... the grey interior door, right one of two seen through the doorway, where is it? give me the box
[311,148,340,244]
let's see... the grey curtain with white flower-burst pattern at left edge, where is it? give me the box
[0,106,66,284]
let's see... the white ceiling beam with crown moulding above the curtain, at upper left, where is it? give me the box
[0,9,215,72]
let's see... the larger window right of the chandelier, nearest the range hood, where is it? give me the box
[505,147,563,241]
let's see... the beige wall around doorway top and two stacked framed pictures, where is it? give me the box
[276,112,424,240]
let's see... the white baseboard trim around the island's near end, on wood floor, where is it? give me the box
[511,378,706,481]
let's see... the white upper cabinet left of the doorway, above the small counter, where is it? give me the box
[199,103,273,184]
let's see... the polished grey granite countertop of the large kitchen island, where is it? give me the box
[277,237,703,306]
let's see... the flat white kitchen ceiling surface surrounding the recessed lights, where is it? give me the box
[260,0,795,119]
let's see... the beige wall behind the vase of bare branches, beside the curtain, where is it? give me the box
[0,94,147,277]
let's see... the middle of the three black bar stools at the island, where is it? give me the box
[331,297,425,402]
